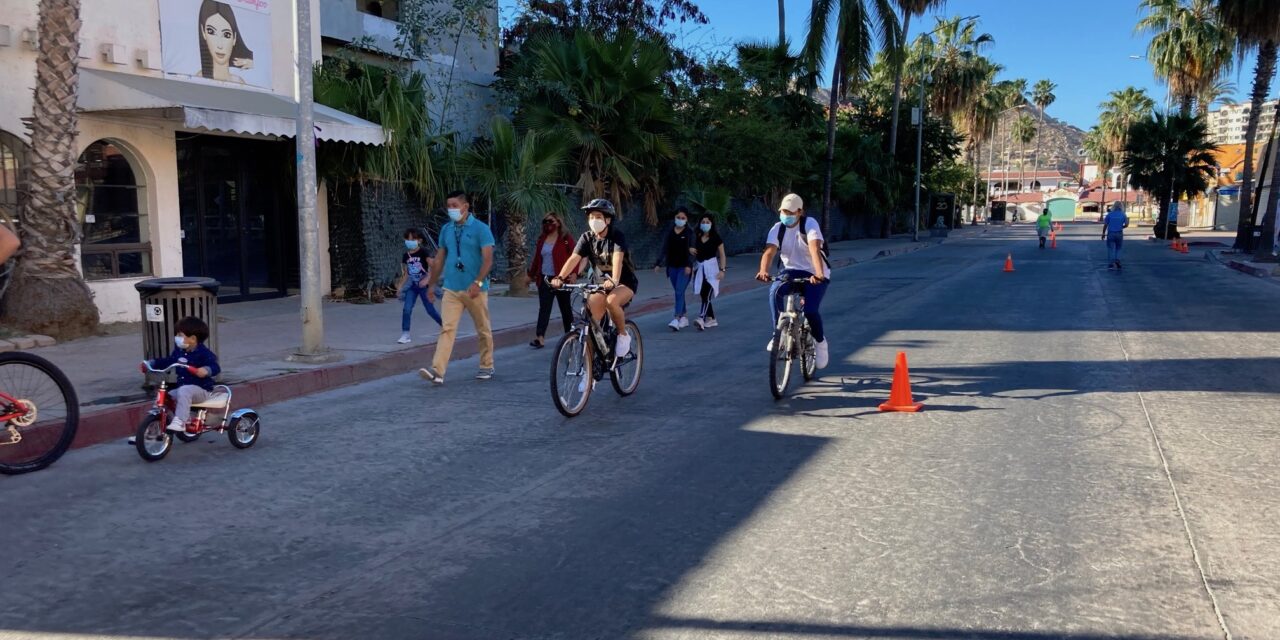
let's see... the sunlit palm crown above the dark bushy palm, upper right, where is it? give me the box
[1138,0,1235,114]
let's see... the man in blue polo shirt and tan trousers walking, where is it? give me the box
[417,191,494,384]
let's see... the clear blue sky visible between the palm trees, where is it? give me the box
[500,0,1274,129]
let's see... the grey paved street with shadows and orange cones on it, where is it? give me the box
[0,224,1280,640]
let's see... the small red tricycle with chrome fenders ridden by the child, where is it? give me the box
[133,362,260,462]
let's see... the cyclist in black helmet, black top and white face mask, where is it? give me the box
[552,198,640,362]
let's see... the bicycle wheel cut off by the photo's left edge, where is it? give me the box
[0,352,79,474]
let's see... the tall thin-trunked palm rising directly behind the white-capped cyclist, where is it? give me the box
[804,0,902,235]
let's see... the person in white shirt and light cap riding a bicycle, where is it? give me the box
[755,193,831,369]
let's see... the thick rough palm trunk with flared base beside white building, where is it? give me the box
[4,0,99,338]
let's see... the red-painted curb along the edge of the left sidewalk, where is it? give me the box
[72,241,941,449]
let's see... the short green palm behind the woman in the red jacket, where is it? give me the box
[460,115,568,296]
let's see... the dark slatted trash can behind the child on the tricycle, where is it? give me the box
[133,278,221,383]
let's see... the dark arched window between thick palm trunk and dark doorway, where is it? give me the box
[76,140,151,280]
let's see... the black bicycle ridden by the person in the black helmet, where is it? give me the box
[552,284,644,417]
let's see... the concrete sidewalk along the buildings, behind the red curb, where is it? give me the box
[35,227,987,447]
